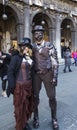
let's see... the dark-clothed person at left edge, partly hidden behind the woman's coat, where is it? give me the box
[0,51,11,97]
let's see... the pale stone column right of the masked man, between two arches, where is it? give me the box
[55,15,61,58]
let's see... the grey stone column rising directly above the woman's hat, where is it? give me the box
[24,5,30,37]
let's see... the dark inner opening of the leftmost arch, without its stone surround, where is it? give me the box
[0,4,17,52]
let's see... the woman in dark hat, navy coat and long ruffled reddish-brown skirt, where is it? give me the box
[7,37,33,130]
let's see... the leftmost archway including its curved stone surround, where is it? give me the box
[0,3,23,52]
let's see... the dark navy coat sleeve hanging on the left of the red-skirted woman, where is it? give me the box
[7,50,23,94]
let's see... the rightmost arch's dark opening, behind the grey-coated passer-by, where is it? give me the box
[61,18,73,58]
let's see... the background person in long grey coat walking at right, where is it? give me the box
[63,48,72,73]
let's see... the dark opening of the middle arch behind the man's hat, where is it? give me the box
[32,12,53,41]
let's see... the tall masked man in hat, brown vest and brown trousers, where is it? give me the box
[32,25,59,130]
